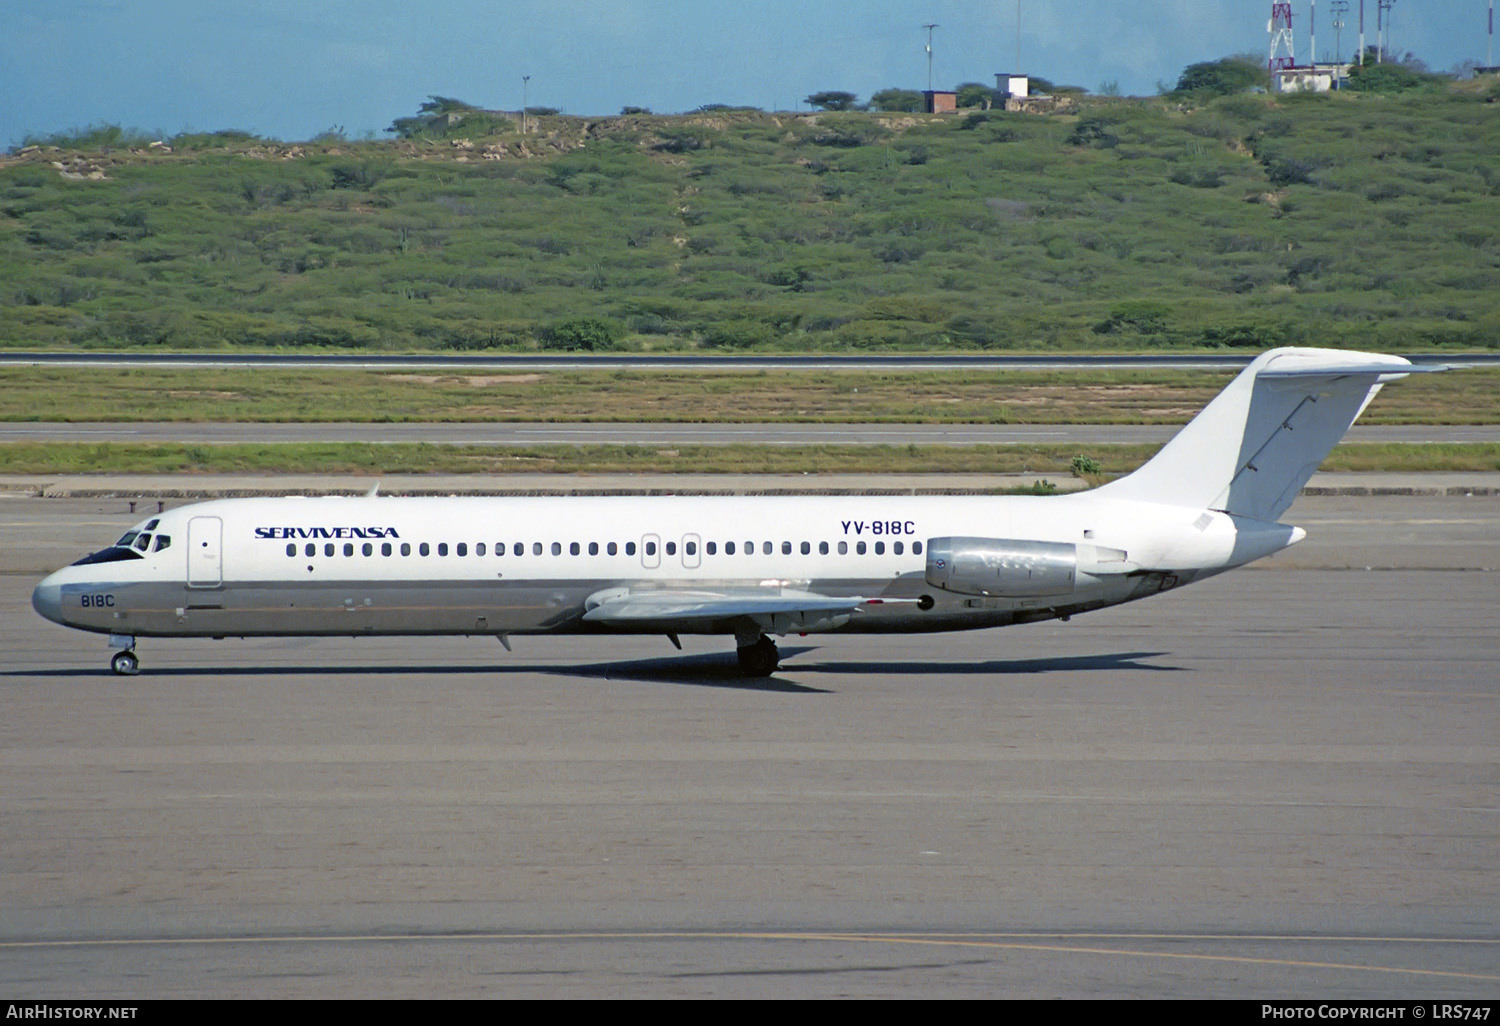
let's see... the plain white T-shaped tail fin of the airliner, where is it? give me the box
[1097,348,1446,521]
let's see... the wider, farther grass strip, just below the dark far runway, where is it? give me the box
[0,368,1500,425]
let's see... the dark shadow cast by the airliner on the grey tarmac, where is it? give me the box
[14,645,1187,695]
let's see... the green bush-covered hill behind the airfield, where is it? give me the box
[0,83,1500,351]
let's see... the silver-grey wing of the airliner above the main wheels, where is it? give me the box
[584,588,879,633]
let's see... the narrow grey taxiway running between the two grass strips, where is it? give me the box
[0,422,1500,446]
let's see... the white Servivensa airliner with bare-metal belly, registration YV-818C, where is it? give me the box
[32,350,1443,677]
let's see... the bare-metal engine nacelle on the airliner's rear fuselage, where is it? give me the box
[927,539,1079,599]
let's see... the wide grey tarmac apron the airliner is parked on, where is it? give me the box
[0,497,1500,1001]
